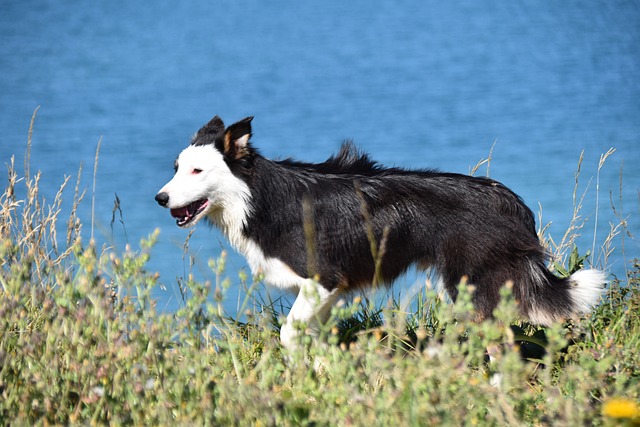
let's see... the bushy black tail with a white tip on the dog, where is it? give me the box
[521,265,607,326]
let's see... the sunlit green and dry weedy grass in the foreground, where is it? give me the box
[0,120,640,426]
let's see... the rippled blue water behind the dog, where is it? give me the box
[0,0,640,313]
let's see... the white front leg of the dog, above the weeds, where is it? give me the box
[280,279,339,351]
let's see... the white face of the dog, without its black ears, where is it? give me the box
[159,145,248,227]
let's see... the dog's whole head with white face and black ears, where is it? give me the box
[155,116,255,227]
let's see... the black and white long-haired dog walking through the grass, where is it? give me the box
[155,116,606,349]
